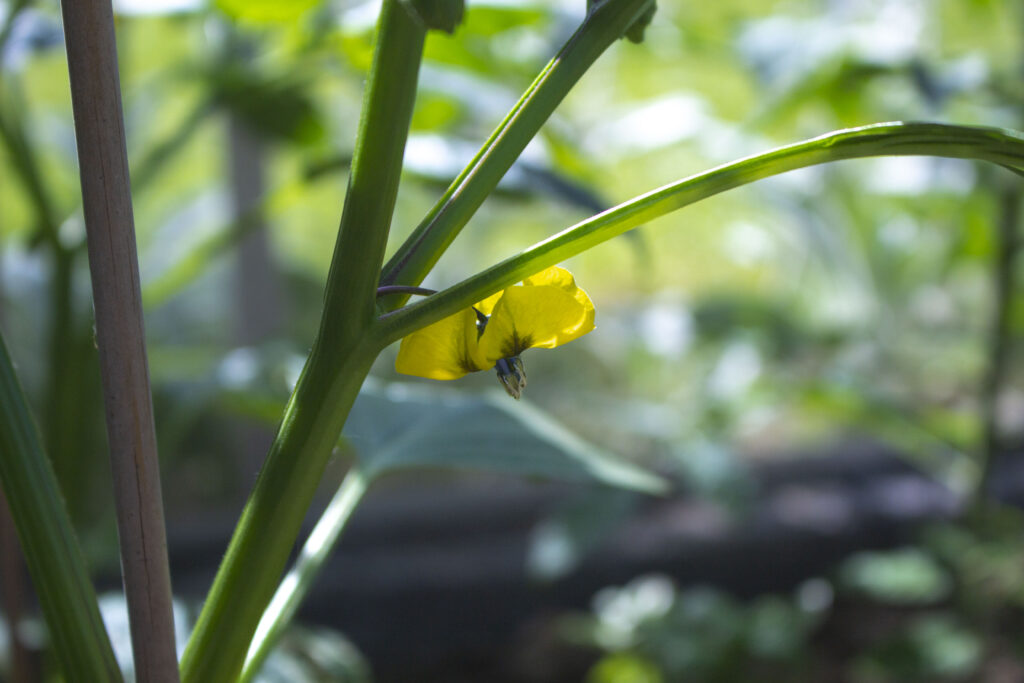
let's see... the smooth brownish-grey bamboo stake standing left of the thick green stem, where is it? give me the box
[60,0,178,683]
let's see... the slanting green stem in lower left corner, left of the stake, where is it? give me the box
[0,338,122,682]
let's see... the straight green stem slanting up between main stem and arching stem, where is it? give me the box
[381,0,651,309]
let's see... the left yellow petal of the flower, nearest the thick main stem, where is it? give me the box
[394,308,485,380]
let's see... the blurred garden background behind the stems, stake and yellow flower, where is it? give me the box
[0,0,1024,683]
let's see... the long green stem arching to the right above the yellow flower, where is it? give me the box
[381,123,1024,342]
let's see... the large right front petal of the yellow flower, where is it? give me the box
[475,284,594,368]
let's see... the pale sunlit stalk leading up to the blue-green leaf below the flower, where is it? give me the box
[239,467,370,683]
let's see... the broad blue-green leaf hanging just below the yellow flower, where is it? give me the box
[345,383,668,493]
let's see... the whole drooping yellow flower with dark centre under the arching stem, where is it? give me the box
[394,266,594,398]
